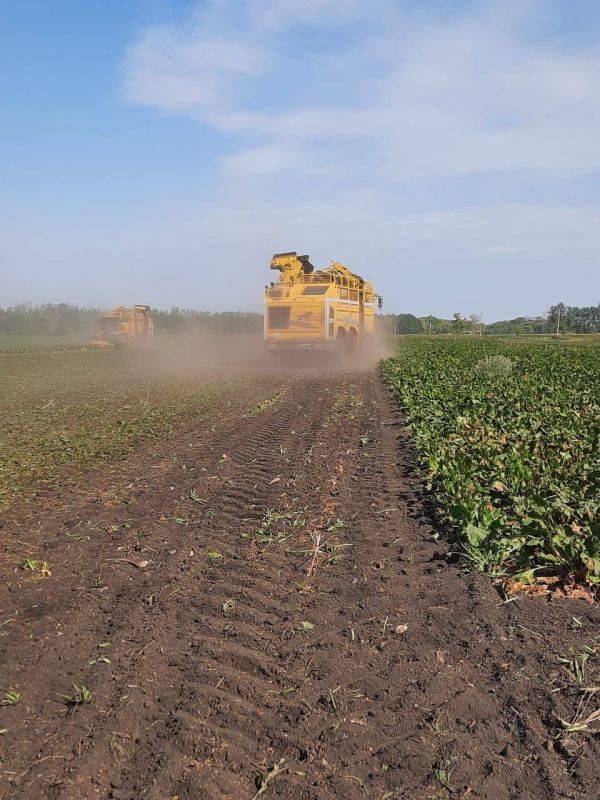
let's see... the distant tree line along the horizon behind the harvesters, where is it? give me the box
[0,303,600,337]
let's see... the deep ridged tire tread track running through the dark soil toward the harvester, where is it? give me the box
[103,376,342,798]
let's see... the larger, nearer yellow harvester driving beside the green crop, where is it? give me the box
[264,252,383,354]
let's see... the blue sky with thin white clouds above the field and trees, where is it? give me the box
[0,0,600,320]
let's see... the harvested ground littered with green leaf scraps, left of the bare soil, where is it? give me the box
[0,348,278,511]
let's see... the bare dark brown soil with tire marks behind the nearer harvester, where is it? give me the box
[0,371,600,800]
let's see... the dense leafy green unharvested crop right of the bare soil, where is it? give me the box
[383,338,600,585]
